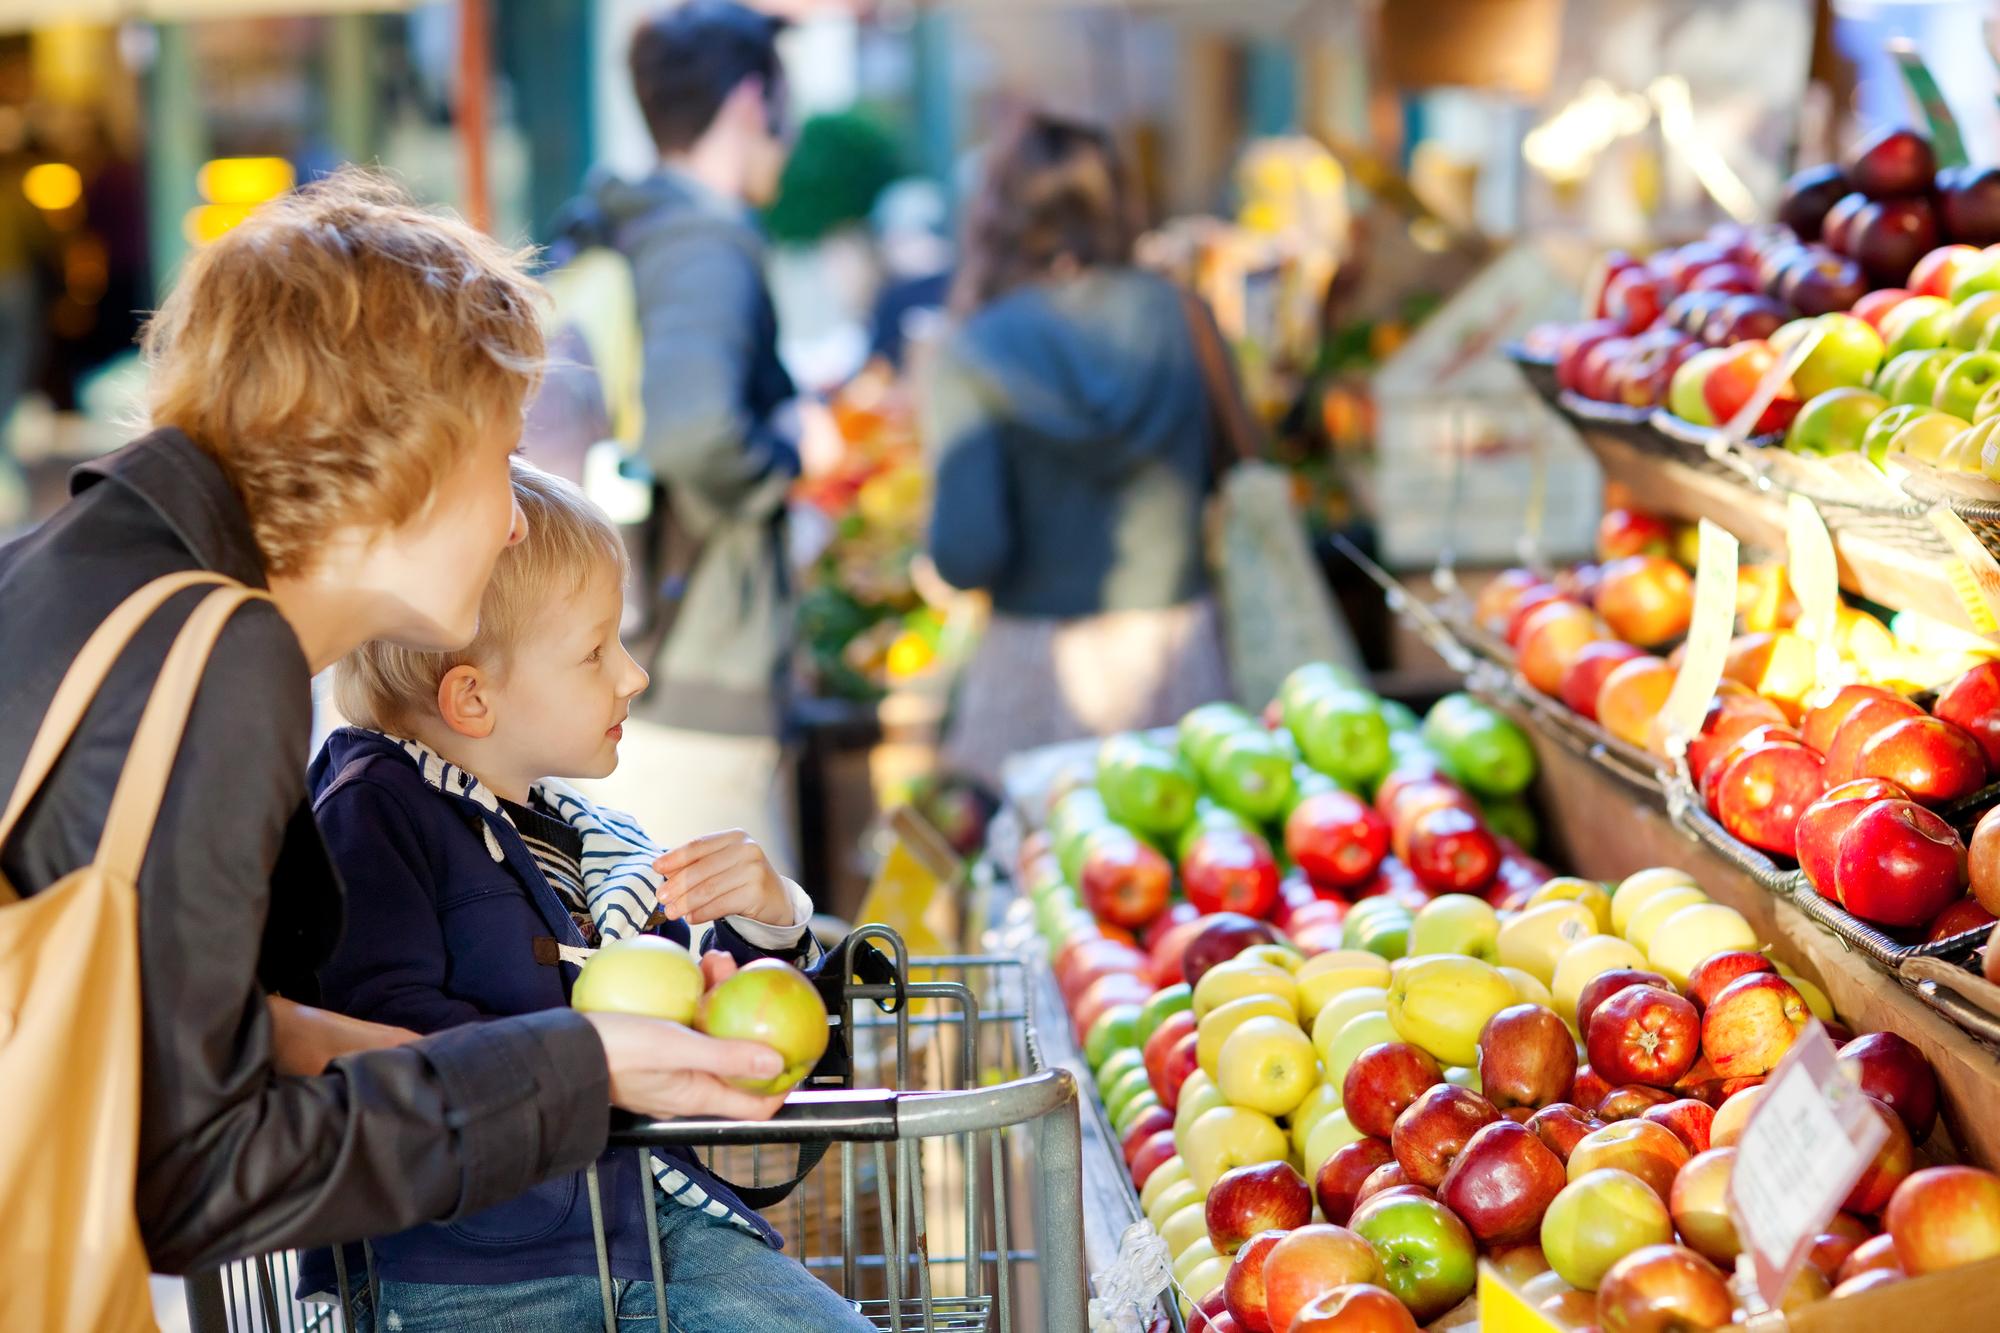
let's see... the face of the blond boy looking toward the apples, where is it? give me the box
[488,566,646,785]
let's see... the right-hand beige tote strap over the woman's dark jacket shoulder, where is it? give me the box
[94,584,270,885]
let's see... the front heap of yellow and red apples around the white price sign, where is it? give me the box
[1058,852,2000,1333]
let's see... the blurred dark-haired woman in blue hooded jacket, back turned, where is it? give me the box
[924,114,1228,785]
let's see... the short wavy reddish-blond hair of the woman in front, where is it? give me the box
[140,168,544,574]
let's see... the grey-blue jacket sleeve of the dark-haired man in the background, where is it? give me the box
[632,228,798,508]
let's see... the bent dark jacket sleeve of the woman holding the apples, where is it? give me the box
[138,608,610,1273]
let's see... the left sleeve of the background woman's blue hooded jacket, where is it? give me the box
[924,348,1014,588]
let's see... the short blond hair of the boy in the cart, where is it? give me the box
[334,462,626,731]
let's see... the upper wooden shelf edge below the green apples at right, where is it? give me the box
[1576,422,1980,634]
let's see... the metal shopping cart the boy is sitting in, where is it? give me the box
[188,927,1088,1333]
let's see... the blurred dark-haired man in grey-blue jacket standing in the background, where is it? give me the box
[548,0,812,869]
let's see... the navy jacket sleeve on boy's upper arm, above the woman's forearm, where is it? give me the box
[314,779,492,1033]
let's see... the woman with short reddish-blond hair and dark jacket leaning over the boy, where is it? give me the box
[0,172,780,1280]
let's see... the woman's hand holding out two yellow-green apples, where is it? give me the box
[586,1013,784,1121]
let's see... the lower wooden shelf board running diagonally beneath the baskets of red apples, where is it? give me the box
[1500,701,2000,1167]
